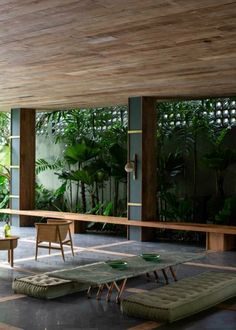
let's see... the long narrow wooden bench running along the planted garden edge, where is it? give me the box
[0,209,236,251]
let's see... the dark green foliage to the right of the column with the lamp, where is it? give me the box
[157,99,236,221]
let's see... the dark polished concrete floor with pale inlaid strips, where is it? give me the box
[0,225,236,330]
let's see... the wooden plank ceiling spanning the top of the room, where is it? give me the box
[0,0,236,110]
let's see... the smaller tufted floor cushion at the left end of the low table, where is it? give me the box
[12,274,87,299]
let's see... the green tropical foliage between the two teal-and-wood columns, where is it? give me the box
[37,106,127,218]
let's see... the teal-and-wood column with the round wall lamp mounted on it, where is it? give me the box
[128,97,157,241]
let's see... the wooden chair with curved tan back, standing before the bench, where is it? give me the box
[35,219,74,261]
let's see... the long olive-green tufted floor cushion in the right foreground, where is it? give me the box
[121,272,236,322]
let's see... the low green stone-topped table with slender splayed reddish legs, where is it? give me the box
[47,252,205,302]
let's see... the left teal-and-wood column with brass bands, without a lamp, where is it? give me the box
[10,108,35,226]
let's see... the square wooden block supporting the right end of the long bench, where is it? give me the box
[206,233,236,251]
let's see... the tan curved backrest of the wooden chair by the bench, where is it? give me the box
[35,219,72,243]
